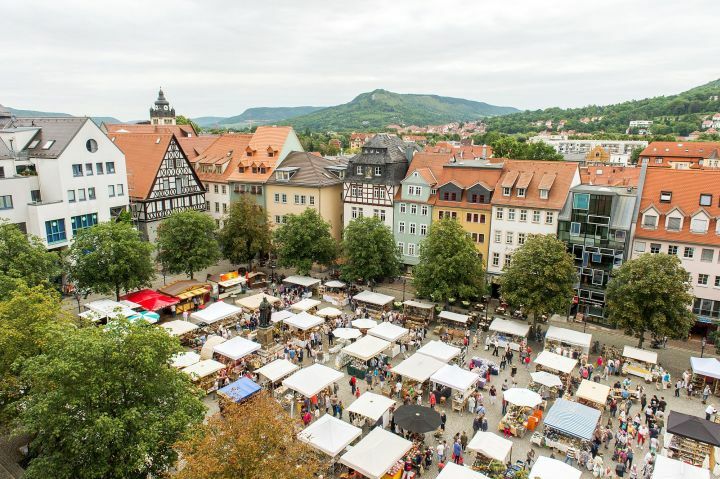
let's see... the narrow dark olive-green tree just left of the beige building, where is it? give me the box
[218,196,271,264]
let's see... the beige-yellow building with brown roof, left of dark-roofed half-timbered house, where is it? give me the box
[265,151,347,241]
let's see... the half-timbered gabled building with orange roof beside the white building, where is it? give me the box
[110,133,207,241]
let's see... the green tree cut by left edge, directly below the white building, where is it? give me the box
[0,221,60,298]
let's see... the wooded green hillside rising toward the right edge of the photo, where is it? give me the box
[487,80,720,136]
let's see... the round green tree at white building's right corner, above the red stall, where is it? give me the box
[69,222,155,299]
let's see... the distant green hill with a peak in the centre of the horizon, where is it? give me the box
[287,90,518,131]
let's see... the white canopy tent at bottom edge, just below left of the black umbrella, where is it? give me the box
[340,427,412,479]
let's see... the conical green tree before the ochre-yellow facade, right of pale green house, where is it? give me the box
[413,218,485,301]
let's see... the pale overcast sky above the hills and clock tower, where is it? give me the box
[0,0,720,120]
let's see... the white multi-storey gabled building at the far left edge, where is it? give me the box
[0,118,128,248]
